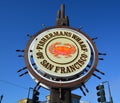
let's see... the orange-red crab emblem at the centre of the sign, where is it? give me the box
[49,42,76,58]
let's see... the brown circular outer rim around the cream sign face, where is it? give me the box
[24,26,98,88]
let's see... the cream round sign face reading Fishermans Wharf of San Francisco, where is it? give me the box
[33,28,91,77]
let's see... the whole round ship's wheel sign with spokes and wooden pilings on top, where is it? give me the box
[17,6,106,94]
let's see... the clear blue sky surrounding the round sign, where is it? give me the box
[0,0,120,103]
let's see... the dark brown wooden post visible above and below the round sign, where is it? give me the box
[50,4,71,103]
